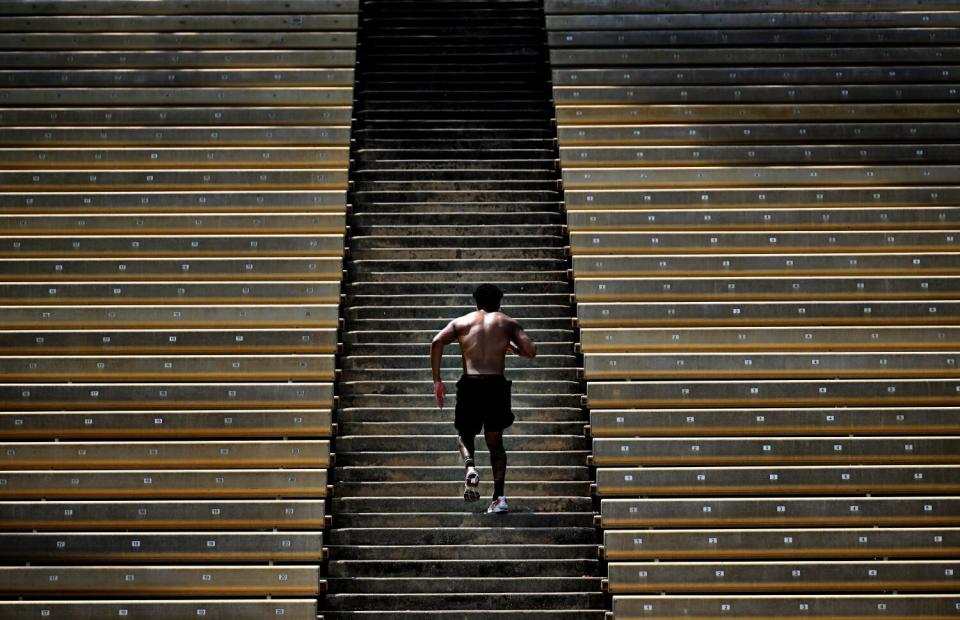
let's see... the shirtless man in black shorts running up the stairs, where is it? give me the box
[430,284,537,512]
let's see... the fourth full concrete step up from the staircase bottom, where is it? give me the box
[330,544,599,560]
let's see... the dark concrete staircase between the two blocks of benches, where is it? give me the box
[324,0,604,620]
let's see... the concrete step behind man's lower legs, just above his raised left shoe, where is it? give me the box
[336,450,589,464]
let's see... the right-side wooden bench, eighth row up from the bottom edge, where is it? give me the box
[587,378,960,409]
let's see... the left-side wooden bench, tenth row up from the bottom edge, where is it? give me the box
[0,328,337,355]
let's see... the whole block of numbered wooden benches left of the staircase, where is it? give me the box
[0,0,358,620]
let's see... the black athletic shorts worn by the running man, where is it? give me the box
[454,375,513,436]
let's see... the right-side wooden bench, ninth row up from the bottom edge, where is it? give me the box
[584,351,958,381]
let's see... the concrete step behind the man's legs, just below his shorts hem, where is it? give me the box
[336,434,588,455]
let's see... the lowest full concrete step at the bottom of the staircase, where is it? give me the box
[324,592,603,617]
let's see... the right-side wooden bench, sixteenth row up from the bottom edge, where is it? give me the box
[564,185,960,213]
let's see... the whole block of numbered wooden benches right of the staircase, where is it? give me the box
[545,0,960,620]
